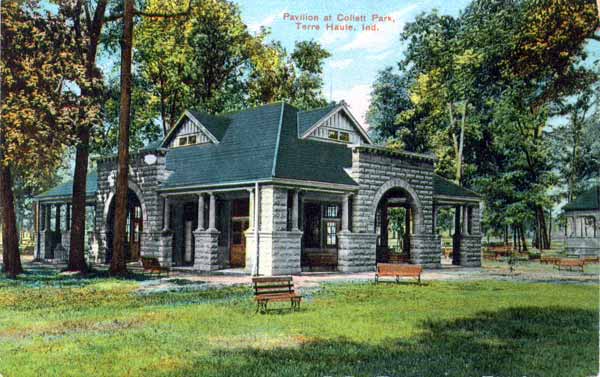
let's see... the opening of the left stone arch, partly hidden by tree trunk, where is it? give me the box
[106,189,144,263]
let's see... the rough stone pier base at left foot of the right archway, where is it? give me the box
[338,231,377,272]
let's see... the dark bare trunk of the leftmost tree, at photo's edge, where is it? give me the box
[0,159,23,278]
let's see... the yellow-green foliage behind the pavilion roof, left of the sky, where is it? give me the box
[135,0,329,135]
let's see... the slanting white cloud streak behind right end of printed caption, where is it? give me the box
[339,4,418,52]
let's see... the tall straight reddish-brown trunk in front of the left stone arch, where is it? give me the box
[110,0,133,275]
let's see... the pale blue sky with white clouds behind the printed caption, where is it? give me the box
[236,0,600,127]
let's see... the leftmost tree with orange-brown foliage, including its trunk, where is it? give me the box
[0,1,84,277]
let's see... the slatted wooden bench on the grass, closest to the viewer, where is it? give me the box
[252,276,302,313]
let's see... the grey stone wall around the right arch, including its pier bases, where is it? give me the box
[339,147,441,271]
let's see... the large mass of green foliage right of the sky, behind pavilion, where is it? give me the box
[369,0,599,235]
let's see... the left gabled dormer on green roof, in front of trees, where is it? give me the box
[162,110,227,148]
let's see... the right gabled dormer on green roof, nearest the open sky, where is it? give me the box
[298,101,373,144]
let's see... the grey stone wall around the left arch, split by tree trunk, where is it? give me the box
[94,151,170,263]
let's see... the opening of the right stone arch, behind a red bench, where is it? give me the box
[375,188,417,263]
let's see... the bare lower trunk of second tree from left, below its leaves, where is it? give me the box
[67,127,90,273]
